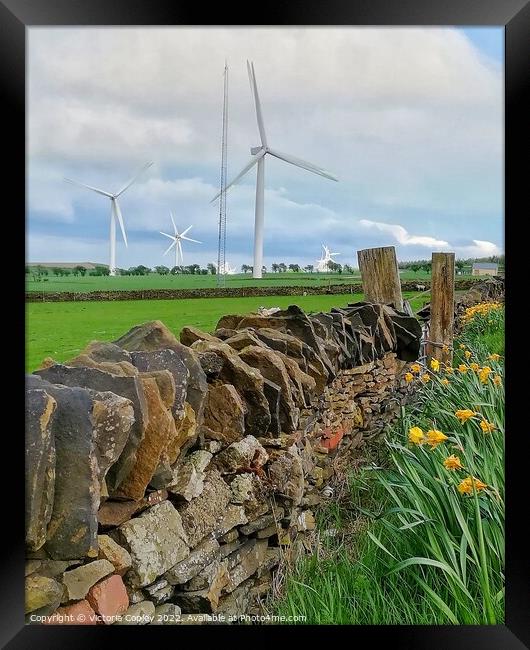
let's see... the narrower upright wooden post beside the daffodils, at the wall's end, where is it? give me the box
[425,253,455,363]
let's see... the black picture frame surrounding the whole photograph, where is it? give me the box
[6,0,530,650]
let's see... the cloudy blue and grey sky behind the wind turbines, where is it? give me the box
[26,27,504,268]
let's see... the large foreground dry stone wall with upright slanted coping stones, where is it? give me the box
[26,303,421,624]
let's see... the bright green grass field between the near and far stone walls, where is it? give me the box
[26,292,428,372]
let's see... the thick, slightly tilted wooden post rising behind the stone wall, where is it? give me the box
[357,246,403,311]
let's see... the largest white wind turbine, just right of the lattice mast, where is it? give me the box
[212,61,338,278]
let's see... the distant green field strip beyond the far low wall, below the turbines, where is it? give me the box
[26,271,446,293]
